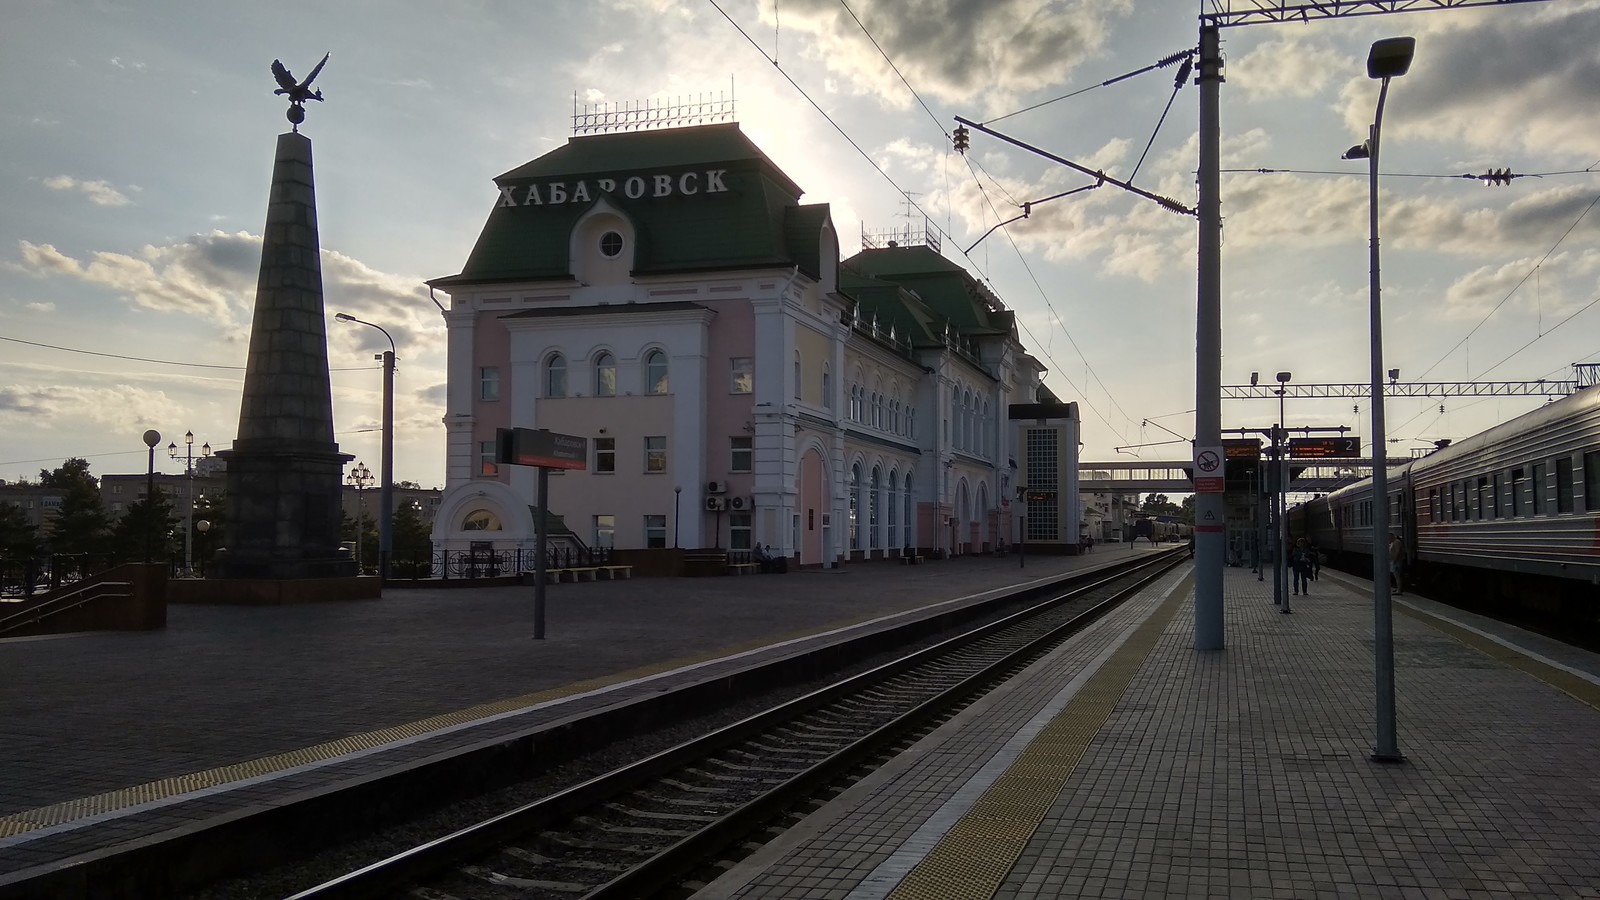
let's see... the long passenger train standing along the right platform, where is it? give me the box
[1290,388,1600,621]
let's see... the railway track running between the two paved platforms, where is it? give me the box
[291,557,1182,900]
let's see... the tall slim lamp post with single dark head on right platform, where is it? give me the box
[1344,37,1416,762]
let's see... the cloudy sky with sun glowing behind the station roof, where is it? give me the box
[0,0,1600,485]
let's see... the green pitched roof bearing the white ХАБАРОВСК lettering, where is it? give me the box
[429,123,827,287]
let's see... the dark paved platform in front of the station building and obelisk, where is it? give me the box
[0,543,1155,897]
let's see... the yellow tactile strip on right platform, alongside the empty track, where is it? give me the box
[890,575,1192,900]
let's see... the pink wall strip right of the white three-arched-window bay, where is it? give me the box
[701,299,755,493]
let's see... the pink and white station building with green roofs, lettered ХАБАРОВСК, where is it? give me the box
[429,123,1077,565]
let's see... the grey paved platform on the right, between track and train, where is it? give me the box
[696,565,1600,900]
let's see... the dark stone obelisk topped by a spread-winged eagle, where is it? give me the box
[218,58,355,586]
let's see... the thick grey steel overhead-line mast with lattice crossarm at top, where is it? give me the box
[1195,0,1542,650]
